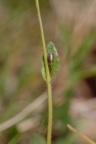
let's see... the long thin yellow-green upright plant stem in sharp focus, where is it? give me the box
[35,0,52,144]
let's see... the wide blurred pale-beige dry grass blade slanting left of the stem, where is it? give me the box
[0,92,47,132]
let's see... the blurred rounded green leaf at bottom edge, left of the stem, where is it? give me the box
[30,134,46,144]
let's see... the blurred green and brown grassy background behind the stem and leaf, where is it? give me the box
[0,0,96,144]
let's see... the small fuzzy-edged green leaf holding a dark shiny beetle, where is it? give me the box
[42,42,59,81]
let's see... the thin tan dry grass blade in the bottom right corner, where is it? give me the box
[67,124,96,144]
